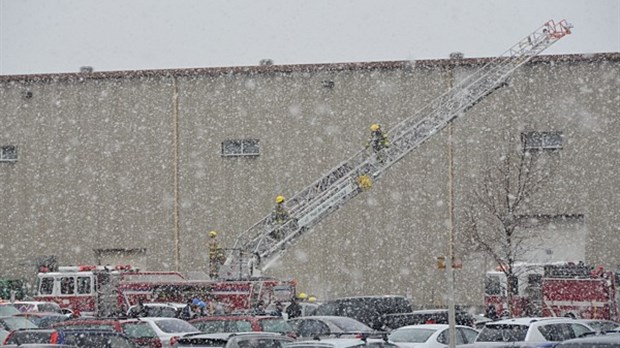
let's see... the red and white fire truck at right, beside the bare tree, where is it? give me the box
[485,262,620,321]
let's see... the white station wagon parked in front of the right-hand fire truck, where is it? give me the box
[475,318,593,344]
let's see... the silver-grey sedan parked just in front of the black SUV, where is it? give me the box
[287,316,381,337]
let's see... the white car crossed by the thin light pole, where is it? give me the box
[388,324,478,348]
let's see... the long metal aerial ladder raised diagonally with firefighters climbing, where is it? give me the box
[219,20,572,279]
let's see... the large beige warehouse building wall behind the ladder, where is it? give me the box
[0,53,620,306]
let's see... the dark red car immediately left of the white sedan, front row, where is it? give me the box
[52,319,162,348]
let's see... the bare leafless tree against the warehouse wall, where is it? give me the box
[463,142,557,315]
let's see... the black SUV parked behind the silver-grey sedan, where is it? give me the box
[314,295,413,330]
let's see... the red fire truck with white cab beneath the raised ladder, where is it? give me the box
[35,265,296,317]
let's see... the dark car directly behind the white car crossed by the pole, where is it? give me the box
[384,309,476,329]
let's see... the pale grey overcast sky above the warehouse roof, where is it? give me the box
[0,0,620,75]
